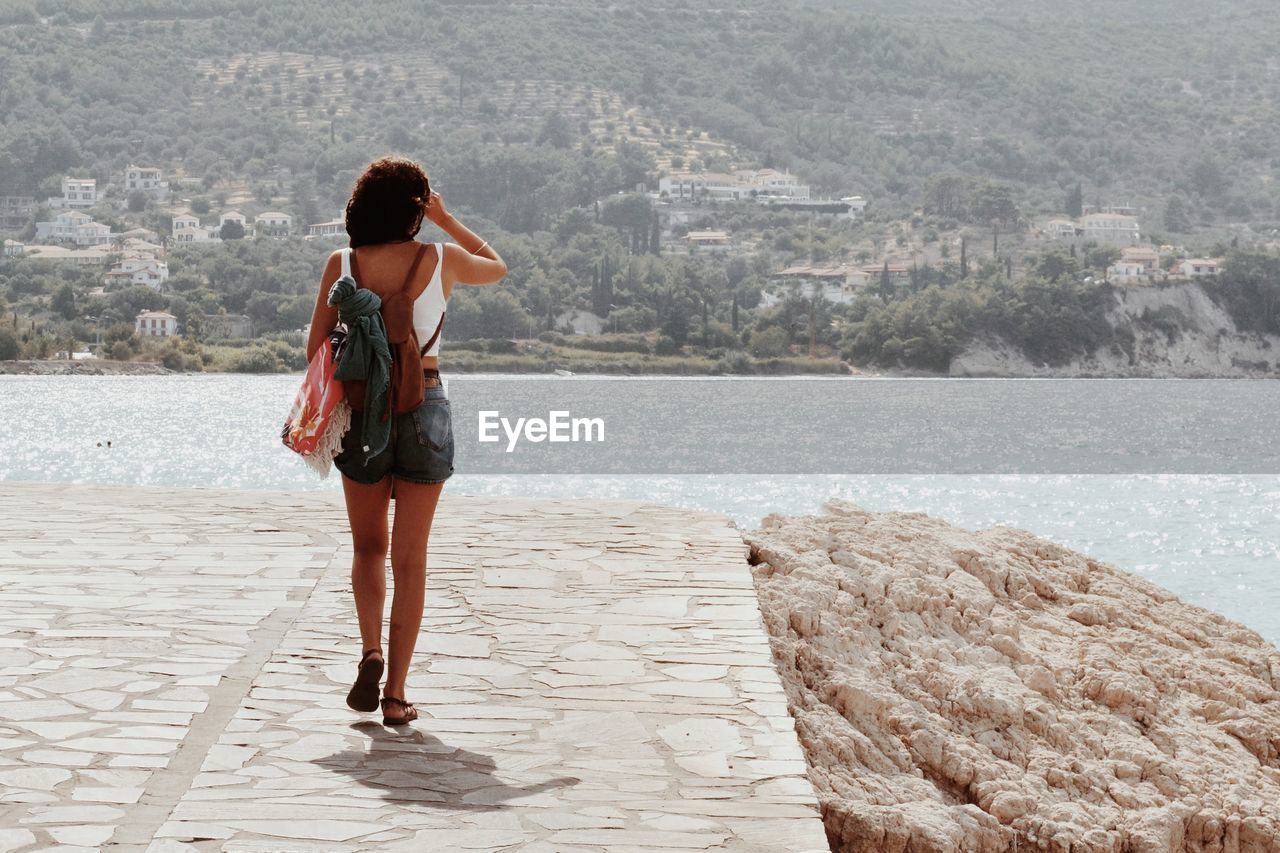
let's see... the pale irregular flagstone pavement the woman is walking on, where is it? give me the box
[0,482,828,853]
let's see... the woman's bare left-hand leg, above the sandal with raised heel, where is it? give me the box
[342,476,392,653]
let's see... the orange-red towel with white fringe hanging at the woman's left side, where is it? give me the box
[280,332,351,476]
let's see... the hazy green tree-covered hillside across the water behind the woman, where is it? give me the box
[0,0,1280,373]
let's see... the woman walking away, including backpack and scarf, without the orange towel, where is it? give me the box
[307,158,507,725]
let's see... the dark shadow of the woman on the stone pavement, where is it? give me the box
[312,721,581,811]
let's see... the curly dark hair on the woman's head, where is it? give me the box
[347,156,431,248]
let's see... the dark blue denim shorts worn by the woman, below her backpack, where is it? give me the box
[333,386,453,485]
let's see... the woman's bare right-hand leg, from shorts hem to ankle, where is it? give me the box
[383,480,444,698]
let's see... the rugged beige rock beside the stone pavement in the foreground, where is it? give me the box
[746,502,1280,853]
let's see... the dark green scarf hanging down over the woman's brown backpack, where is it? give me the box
[329,275,392,465]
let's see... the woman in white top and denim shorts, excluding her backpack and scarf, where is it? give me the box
[307,158,507,725]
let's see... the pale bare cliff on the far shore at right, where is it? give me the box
[950,282,1280,378]
